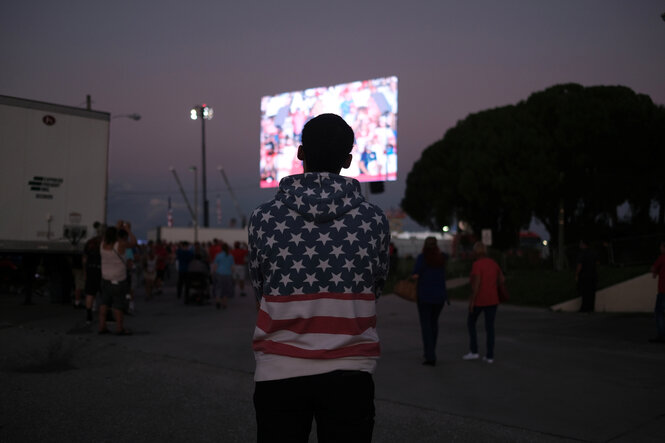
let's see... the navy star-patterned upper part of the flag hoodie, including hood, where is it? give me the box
[248,173,390,296]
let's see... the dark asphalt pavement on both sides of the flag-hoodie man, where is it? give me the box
[0,287,665,442]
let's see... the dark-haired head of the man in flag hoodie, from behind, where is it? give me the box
[302,114,355,174]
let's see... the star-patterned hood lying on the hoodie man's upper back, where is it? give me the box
[275,172,365,223]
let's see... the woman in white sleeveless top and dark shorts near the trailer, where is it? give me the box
[99,221,136,335]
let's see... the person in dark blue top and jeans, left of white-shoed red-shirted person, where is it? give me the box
[412,237,448,366]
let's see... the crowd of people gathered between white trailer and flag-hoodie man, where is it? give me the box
[79,220,247,335]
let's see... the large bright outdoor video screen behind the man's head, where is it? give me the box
[260,76,397,188]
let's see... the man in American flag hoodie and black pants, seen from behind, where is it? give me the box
[248,114,390,443]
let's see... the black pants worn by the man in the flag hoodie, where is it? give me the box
[254,371,374,443]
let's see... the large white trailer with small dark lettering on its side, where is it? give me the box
[0,95,110,252]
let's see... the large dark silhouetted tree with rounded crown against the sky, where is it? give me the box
[402,84,665,248]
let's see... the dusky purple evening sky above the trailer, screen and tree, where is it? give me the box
[0,0,665,237]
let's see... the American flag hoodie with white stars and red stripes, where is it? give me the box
[248,172,390,381]
